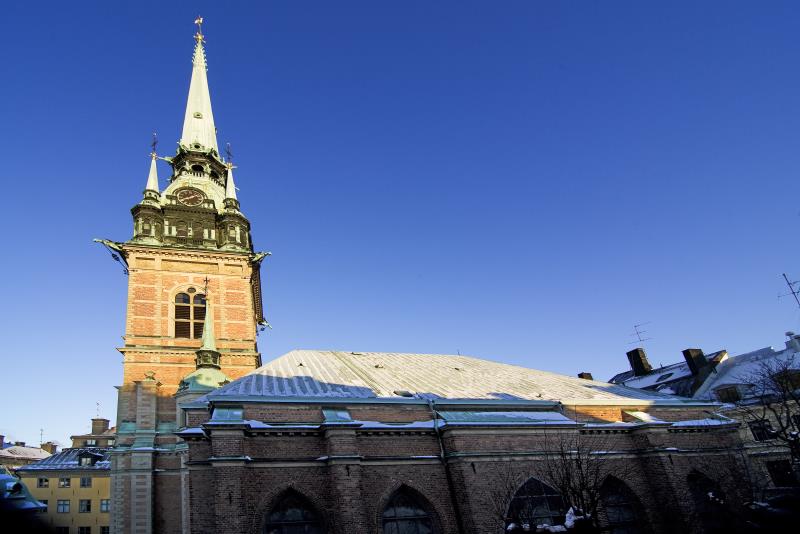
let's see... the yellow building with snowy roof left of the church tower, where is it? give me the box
[17,447,111,534]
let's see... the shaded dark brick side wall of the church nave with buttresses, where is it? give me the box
[178,402,739,534]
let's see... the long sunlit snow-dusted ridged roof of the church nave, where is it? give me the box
[207,350,675,402]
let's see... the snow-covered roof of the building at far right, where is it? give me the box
[694,347,800,400]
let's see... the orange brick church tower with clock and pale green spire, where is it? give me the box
[102,19,266,534]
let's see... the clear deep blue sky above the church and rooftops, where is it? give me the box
[0,0,800,444]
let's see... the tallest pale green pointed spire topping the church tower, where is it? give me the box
[180,17,219,152]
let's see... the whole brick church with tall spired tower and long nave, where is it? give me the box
[101,19,756,534]
